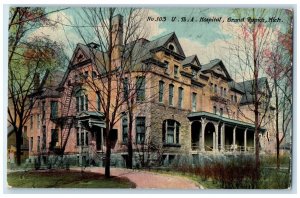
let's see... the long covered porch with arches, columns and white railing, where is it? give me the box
[188,112,264,152]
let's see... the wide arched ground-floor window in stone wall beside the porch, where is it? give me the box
[163,120,180,144]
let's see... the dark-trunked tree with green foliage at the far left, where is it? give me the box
[8,7,66,165]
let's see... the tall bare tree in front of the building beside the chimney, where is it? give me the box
[71,8,149,177]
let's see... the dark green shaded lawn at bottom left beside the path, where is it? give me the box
[7,170,135,188]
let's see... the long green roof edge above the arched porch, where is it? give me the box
[187,111,266,132]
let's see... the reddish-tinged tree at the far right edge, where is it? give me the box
[265,10,293,168]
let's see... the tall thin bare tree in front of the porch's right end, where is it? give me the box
[227,8,286,176]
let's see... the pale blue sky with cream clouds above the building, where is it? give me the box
[32,7,288,79]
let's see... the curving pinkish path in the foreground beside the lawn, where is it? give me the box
[74,167,203,189]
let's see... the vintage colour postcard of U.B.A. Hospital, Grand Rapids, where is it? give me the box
[6,6,294,191]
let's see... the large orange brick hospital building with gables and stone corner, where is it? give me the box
[27,15,273,166]
